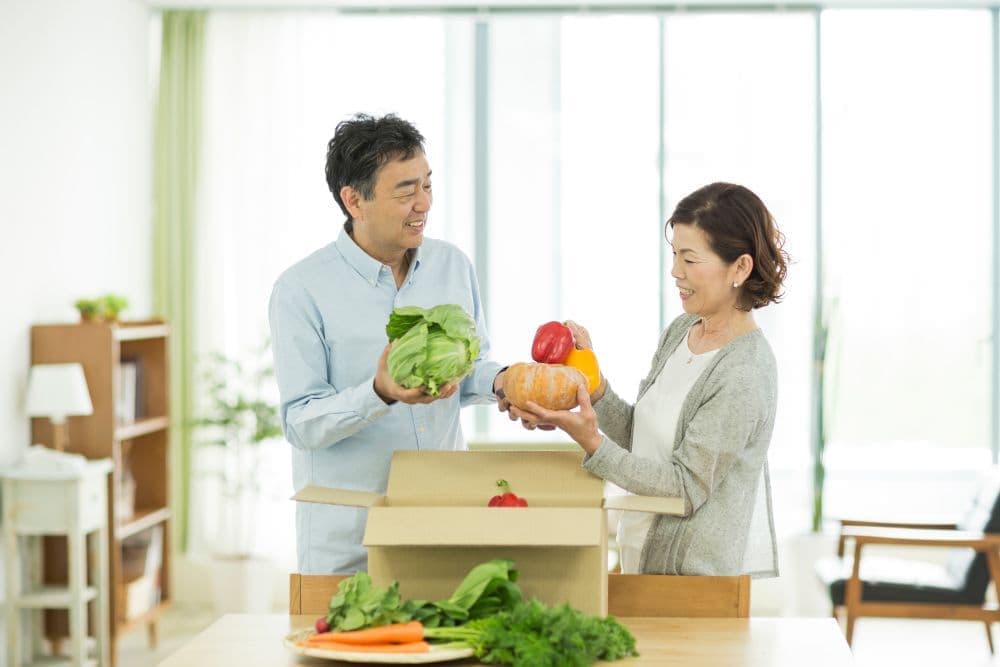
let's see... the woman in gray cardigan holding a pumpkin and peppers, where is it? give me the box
[510,183,788,576]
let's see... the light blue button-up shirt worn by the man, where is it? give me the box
[270,230,500,574]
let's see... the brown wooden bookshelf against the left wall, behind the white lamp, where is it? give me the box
[31,320,171,664]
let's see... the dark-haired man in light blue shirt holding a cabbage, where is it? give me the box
[270,114,506,574]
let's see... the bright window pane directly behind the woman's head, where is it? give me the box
[663,12,816,467]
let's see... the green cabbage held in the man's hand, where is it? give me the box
[385,304,479,396]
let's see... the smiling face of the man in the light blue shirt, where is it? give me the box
[352,153,434,261]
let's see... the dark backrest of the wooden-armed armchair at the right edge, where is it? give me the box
[946,467,1000,604]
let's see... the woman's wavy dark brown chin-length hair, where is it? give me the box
[667,183,789,311]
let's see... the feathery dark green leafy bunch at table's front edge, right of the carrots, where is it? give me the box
[424,600,639,667]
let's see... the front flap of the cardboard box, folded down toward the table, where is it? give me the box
[364,507,607,547]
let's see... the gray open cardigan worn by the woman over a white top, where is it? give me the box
[583,314,778,576]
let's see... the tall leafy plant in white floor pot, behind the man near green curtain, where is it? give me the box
[193,347,281,612]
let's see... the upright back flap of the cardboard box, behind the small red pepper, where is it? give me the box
[386,450,604,507]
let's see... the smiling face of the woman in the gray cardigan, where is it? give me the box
[670,225,738,318]
